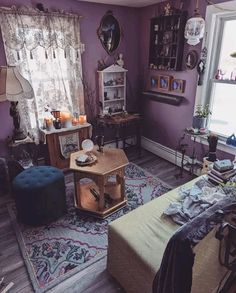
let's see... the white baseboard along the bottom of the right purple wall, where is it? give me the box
[141,136,201,175]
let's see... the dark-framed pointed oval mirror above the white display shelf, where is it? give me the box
[97,11,121,55]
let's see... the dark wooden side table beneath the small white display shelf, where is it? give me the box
[97,114,142,153]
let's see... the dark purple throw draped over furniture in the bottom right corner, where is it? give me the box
[153,197,236,293]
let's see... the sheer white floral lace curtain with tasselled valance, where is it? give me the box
[0,7,84,142]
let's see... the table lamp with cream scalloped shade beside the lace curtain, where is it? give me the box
[0,66,34,141]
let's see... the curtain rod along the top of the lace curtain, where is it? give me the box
[0,6,83,18]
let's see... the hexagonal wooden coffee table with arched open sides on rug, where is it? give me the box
[70,146,129,218]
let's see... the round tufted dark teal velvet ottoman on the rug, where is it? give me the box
[12,166,66,225]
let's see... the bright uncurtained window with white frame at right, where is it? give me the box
[196,1,236,138]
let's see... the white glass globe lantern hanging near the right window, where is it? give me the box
[184,0,205,46]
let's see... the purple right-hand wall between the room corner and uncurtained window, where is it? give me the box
[139,0,233,158]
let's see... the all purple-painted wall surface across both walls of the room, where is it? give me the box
[0,0,232,161]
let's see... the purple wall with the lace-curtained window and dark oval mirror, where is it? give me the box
[0,0,139,155]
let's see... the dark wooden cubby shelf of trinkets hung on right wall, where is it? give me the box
[149,11,187,71]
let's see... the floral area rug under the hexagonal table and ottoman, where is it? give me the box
[8,163,170,292]
